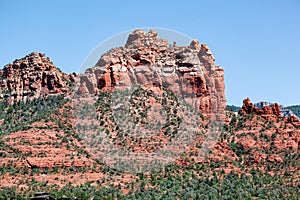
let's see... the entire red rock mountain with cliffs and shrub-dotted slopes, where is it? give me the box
[0,31,300,199]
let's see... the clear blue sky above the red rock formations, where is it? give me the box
[0,0,300,105]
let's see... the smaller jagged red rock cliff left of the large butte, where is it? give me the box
[0,53,76,103]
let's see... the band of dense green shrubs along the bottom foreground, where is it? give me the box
[0,165,300,199]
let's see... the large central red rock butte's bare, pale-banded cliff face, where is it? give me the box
[77,30,226,121]
